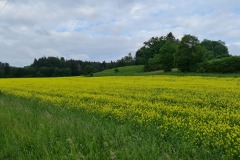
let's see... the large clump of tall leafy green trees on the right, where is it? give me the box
[135,32,230,72]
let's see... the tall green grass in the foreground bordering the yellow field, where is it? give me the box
[0,93,224,160]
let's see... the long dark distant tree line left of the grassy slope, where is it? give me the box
[0,53,134,77]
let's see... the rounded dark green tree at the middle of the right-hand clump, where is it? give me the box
[176,35,206,72]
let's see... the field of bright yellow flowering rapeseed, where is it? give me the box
[0,76,240,158]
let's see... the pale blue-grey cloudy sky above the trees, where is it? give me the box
[0,0,240,67]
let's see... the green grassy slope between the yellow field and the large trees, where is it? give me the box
[93,65,240,77]
